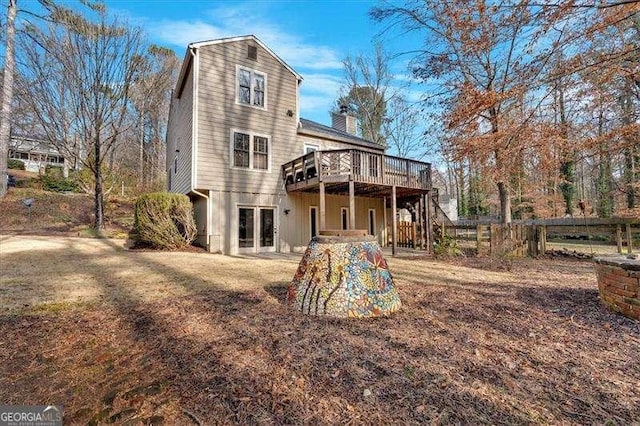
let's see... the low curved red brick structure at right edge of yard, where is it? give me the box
[596,256,640,321]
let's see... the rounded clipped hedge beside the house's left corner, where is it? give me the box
[133,192,197,250]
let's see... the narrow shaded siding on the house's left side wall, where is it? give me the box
[167,68,193,194]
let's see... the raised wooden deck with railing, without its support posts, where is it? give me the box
[282,149,431,197]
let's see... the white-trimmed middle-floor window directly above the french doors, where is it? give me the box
[231,130,271,170]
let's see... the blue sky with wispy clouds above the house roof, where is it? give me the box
[97,0,420,124]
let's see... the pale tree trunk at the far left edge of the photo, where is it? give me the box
[0,0,18,198]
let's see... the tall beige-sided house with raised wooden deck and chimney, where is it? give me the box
[166,35,431,254]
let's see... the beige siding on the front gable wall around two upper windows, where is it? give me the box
[196,40,302,193]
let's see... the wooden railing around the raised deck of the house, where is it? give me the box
[282,149,431,189]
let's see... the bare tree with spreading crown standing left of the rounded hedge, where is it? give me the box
[22,10,142,230]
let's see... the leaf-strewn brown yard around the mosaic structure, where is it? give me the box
[0,235,640,425]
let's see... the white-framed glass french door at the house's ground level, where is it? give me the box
[238,206,277,253]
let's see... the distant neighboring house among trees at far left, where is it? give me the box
[9,135,65,173]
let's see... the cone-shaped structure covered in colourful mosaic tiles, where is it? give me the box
[288,236,401,318]
